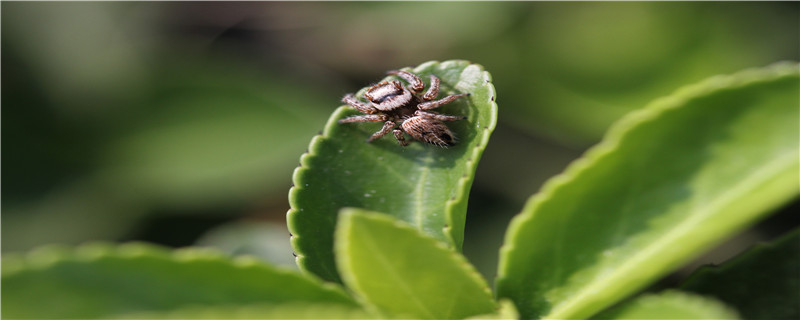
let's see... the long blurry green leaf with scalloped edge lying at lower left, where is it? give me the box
[2,244,355,319]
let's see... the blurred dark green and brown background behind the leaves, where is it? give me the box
[0,2,800,279]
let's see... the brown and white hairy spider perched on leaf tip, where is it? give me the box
[339,70,469,147]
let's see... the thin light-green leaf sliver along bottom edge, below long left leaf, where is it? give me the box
[118,303,375,319]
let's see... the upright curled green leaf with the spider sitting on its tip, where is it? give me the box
[287,60,497,281]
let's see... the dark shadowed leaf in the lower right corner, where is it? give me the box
[681,230,800,319]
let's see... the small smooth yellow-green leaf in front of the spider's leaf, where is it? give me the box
[336,209,495,319]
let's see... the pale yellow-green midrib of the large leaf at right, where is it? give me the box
[544,149,797,319]
